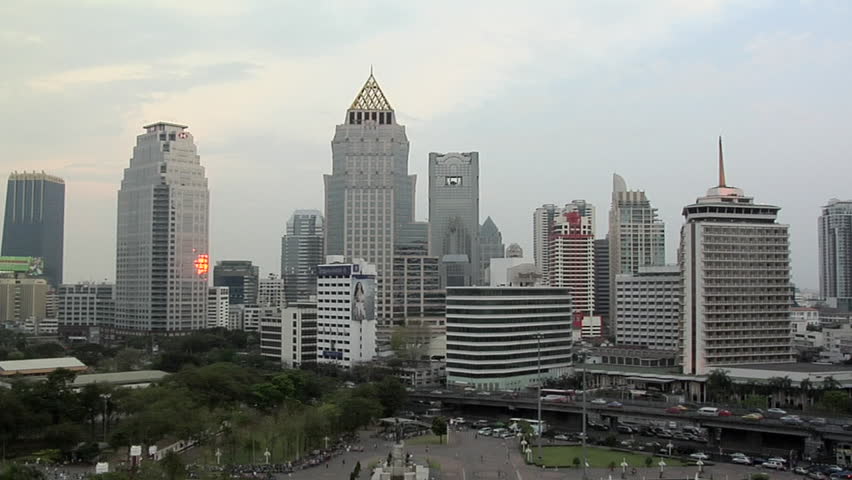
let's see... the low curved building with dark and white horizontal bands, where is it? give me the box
[447,287,573,390]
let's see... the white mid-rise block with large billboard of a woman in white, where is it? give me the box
[317,255,376,368]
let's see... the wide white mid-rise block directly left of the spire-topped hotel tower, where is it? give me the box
[613,265,681,350]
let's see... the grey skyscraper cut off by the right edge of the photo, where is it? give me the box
[819,198,852,310]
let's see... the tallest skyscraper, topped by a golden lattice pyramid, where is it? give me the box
[324,73,417,318]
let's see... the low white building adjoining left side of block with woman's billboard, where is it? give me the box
[260,302,317,368]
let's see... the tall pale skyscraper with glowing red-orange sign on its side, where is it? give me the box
[115,122,210,333]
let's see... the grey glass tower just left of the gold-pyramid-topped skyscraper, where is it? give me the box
[281,210,324,302]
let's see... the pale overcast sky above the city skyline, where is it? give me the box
[0,0,852,288]
